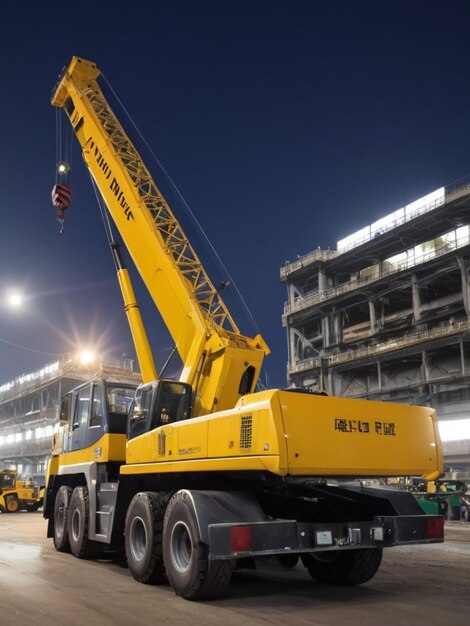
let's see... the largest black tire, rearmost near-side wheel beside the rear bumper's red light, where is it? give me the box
[163,491,233,600]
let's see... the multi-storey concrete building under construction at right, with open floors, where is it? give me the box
[281,182,470,469]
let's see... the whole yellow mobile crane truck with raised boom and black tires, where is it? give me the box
[44,57,443,600]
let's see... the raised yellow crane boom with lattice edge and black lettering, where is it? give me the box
[52,57,269,414]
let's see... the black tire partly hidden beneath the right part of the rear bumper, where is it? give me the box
[302,548,382,585]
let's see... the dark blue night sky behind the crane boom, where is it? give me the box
[0,0,470,386]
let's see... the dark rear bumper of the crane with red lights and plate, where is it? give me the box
[209,515,444,560]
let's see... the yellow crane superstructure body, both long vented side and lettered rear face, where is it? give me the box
[121,390,443,477]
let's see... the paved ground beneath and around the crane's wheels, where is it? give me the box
[0,512,470,626]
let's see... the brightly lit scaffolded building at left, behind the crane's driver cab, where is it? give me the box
[0,355,141,483]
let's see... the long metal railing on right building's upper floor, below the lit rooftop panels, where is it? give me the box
[284,236,470,315]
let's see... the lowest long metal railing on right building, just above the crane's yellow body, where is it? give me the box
[288,320,470,374]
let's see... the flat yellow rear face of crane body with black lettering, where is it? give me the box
[279,392,443,476]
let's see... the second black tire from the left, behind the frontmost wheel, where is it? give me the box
[67,487,103,559]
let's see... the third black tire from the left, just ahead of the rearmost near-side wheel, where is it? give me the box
[124,491,167,585]
